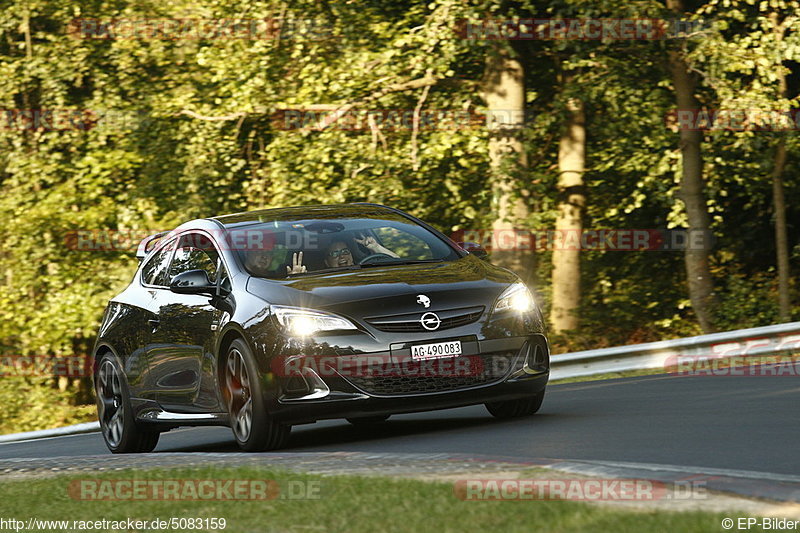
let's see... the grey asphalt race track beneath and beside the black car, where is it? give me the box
[0,376,800,474]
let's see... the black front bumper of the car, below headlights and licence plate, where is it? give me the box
[267,334,550,424]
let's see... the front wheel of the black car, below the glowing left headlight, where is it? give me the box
[222,339,292,452]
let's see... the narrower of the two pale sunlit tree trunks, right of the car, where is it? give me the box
[550,95,586,333]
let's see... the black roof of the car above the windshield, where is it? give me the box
[211,202,400,228]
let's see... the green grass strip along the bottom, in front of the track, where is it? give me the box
[0,467,760,533]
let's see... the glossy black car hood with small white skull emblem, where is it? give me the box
[247,256,518,317]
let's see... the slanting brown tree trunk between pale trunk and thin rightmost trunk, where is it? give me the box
[667,0,715,333]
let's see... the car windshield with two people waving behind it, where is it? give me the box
[228,214,460,279]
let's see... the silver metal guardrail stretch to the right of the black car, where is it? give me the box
[550,322,800,380]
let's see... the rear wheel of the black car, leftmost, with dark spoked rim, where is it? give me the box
[94,353,160,453]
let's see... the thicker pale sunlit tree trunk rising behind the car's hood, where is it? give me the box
[483,44,533,282]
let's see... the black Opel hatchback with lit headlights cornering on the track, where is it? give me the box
[93,204,550,453]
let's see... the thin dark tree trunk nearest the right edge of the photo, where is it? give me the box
[770,11,792,322]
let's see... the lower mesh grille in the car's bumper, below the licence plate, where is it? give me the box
[346,352,518,396]
